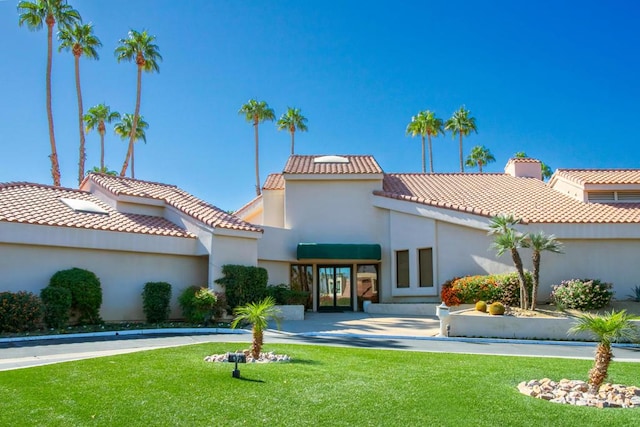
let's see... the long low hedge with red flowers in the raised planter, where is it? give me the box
[440,272,533,306]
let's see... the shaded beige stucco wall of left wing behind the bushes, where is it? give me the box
[0,243,207,321]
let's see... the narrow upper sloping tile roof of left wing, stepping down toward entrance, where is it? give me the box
[85,173,262,232]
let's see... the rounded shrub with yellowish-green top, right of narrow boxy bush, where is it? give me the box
[178,286,227,323]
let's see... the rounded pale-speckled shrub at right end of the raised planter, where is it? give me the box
[551,279,613,310]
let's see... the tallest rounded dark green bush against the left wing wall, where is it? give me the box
[49,268,102,325]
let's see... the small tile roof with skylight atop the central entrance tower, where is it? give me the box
[283,155,383,174]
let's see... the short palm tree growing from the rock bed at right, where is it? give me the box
[569,310,639,393]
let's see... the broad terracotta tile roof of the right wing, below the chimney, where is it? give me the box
[374,174,640,223]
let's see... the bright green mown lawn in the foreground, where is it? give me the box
[0,343,640,426]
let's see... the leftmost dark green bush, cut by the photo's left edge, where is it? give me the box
[0,291,44,332]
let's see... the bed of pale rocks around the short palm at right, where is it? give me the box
[518,378,640,408]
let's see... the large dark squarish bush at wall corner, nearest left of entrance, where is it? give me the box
[216,264,269,309]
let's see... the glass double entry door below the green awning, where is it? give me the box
[318,265,353,311]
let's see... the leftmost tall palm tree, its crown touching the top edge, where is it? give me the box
[18,0,82,186]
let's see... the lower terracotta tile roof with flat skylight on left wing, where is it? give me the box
[0,182,195,238]
